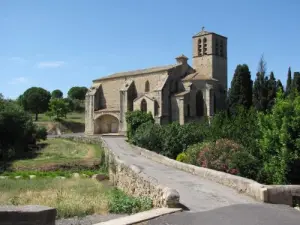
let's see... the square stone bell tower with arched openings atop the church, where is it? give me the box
[193,27,227,90]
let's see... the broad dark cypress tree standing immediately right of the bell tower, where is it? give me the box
[228,64,253,112]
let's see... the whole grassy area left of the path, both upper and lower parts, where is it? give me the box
[0,139,152,218]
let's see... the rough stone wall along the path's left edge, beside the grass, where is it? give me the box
[59,136,179,207]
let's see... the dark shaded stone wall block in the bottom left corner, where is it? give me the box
[0,205,56,225]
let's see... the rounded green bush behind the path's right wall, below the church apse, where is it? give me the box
[132,121,163,153]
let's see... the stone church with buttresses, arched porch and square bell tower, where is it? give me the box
[85,28,227,135]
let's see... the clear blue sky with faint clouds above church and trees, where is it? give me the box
[0,0,300,98]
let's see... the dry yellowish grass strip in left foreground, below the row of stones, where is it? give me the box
[0,178,152,218]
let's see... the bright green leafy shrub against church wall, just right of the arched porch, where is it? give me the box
[126,110,154,141]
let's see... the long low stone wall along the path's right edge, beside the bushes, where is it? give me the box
[134,146,300,206]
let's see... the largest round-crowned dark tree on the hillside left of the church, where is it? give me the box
[19,87,51,121]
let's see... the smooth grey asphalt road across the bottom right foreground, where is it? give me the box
[142,204,300,225]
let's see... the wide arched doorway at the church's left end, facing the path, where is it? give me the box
[95,114,119,134]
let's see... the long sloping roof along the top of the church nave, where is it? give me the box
[94,64,180,82]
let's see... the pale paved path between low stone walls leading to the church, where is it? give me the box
[103,136,261,212]
